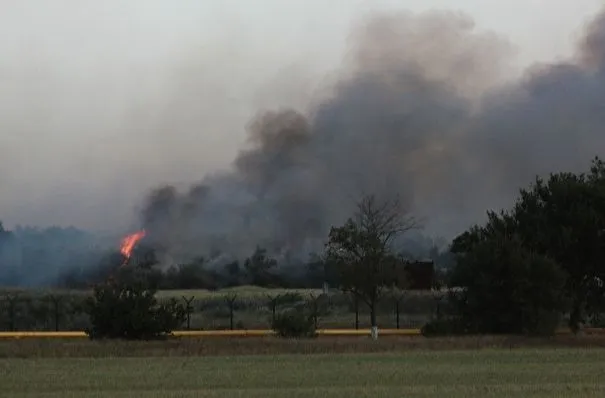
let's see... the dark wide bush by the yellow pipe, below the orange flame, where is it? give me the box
[86,281,186,340]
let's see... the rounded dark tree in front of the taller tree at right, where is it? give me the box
[450,231,565,335]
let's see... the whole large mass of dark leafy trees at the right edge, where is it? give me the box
[451,158,605,330]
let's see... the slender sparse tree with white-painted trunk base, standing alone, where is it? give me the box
[325,195,417,339]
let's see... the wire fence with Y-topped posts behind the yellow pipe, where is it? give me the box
[0,292,448,331]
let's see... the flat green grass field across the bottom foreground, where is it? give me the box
[0,348,605,398]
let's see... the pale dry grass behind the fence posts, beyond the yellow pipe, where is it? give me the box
[0,286,436,331]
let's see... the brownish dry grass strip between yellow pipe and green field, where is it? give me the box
[0,336,605,358]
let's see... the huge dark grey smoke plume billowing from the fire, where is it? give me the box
[137,7,605,264]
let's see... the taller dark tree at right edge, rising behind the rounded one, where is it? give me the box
[452,158,605,331]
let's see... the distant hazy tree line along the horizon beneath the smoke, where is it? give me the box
[0,222,451,290]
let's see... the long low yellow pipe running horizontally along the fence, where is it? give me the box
[0,328,605,339]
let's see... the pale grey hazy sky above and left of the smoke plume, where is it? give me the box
[0,0,602,230]
